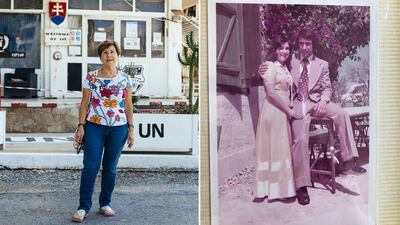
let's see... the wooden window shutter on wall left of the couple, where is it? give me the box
[217,4,261,93]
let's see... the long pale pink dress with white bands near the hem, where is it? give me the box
[256,62,296,200]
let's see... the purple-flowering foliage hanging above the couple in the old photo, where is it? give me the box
[261,4,370,80]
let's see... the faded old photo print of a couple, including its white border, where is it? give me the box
[208,0,377,225]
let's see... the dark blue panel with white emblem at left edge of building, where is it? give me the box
[0,13,41,68]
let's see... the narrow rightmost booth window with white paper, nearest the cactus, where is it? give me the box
[151,19,165,58]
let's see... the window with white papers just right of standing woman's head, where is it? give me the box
[120,20,146,58]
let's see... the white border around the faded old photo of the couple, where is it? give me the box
[207,0,378,225]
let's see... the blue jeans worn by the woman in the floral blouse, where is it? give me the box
[78,121,128,212]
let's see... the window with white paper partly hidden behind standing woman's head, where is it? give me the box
[88,20,114,57]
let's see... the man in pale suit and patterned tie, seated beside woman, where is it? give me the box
[259,30,366,205]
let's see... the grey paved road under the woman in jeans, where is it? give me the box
[0,169,198,225]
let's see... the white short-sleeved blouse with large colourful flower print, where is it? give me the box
[82,70,132,126]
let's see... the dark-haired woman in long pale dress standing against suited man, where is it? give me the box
[254,35,302,202]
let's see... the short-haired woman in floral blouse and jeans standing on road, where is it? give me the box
[72,40,134,222]
